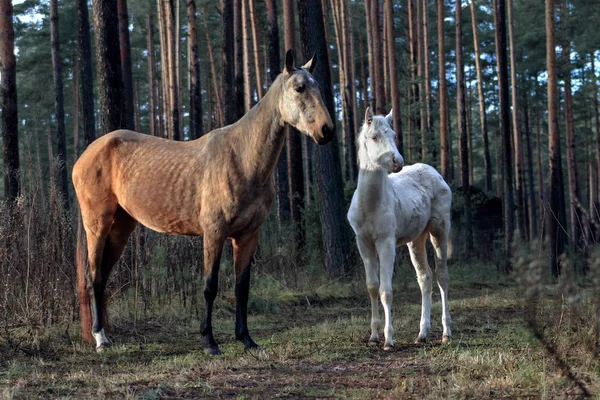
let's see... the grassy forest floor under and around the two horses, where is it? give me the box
[0,265,600,399]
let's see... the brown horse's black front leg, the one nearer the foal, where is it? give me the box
[233,232,259,349]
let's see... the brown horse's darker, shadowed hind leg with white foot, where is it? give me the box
[92,206,137,351]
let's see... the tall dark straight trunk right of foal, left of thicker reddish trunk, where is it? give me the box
[494,0,515,272]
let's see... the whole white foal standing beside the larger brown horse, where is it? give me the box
[348,109,452,350]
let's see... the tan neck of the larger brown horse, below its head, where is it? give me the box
[232,80,285,185]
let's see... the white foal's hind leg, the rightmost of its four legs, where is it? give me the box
[430,220,452,343]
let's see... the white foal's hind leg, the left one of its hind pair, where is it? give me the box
[408,231,431,343]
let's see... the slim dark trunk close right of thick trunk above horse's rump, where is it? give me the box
[117,0,134,130]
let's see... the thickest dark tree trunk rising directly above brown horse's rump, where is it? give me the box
[92,0,124,134]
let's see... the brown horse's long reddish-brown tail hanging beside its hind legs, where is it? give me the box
[75,213,94,343]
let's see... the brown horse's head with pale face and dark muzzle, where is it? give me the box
[279,50,334,144]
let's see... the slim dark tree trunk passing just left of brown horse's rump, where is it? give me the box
[50,0,69,210]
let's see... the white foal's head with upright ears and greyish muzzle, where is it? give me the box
[357,108,404,172]
